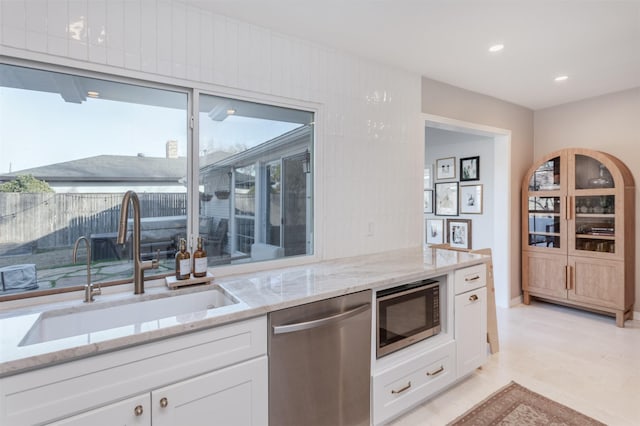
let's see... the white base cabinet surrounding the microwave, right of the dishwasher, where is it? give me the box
[372,263,487,425]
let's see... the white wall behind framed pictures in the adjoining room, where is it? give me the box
[425,127,494,249]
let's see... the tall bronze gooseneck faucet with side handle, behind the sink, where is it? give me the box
[118,191,159,294]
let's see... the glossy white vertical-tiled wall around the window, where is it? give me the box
[0,0,423,258]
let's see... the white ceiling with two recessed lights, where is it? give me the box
[184,0,640,110]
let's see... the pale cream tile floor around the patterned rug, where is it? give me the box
[392,301,640,426]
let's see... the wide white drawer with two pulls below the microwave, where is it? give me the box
[373,341,456,424]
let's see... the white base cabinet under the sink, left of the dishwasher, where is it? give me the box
[0,316,268,426]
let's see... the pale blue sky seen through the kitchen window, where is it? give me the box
[0,87,299,174]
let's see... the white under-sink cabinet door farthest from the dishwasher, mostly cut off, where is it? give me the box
[49,393,151,426]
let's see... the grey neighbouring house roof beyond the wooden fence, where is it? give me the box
[0,155,187,184]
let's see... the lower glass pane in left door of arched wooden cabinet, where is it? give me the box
[528,196,561,248]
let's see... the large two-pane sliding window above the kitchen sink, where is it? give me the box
[0,64,313,300]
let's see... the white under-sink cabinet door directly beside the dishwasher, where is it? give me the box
[151,356,268,426]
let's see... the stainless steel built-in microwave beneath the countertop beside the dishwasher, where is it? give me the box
[376,279,441,358]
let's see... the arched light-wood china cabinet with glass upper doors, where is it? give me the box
[522,148,635,327]
